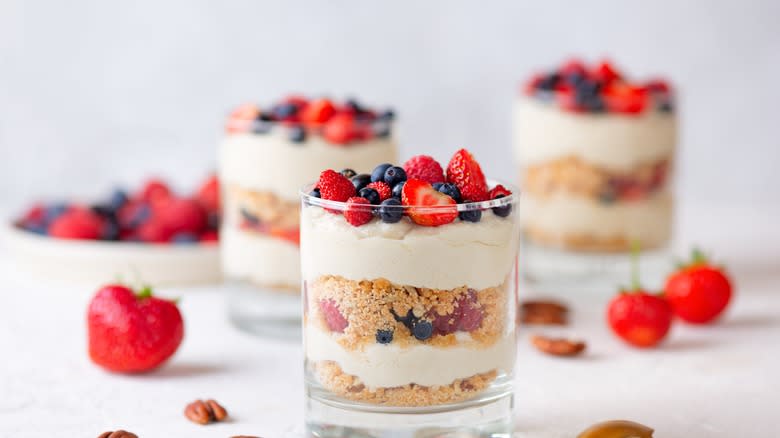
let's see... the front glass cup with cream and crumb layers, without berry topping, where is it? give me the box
[301,186,520,438]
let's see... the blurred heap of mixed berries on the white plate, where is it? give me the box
[15,176,219,243]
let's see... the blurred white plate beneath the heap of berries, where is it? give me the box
[0,223,222,286]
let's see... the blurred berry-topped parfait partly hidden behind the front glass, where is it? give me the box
[219,97,397,335]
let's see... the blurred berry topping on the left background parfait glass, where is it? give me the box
[225,96,394,145]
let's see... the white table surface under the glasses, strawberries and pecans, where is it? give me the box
[0,206,780,438]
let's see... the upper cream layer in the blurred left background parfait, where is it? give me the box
[219,130,398,200]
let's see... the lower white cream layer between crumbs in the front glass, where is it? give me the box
[305,324,517,390]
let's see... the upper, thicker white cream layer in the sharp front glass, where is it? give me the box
[301,206,520,290]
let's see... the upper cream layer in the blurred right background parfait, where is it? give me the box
[514,96,677,171]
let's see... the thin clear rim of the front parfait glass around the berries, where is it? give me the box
[298,179,520,213]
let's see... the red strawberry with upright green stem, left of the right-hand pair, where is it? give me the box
[607,290,672,348]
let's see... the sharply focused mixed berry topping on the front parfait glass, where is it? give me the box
[310,149,512,227]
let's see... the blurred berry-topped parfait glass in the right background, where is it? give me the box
[514,60,677,278]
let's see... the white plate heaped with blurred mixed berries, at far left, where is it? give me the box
[2,175,221,285]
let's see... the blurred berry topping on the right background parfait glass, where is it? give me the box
[524,59,673,114]
